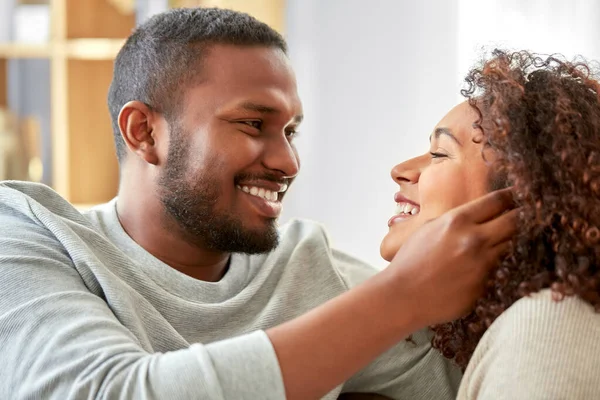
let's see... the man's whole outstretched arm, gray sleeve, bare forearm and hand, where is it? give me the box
[0,188,514,399]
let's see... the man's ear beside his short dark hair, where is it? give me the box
[119,100,159,165]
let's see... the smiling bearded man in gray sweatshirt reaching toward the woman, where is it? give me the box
[0,9,514,399]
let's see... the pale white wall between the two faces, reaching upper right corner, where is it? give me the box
[283,0,600,266]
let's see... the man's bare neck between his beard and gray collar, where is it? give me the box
[117,192,230,282]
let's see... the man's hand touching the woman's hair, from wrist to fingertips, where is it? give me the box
[387,189,518,327]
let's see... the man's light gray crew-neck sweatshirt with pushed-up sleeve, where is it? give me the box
[0,182,460,400]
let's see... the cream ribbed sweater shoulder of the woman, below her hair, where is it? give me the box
[458,290,600,400]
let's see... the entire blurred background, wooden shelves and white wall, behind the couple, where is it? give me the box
[0,0,600,267]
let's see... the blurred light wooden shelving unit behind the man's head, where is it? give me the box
[0,0,285,206]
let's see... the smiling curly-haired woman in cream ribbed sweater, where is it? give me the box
[381,51,600,399]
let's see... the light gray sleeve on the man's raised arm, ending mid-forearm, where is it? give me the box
[0,202,285,400]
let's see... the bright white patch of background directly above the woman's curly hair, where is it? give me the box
[458,0,600,97]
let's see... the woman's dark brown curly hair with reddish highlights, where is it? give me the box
[433,50,600,369]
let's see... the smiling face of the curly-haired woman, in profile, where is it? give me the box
[380,102,493,261]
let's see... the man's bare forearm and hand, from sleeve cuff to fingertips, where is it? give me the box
[267,190,518,400]
